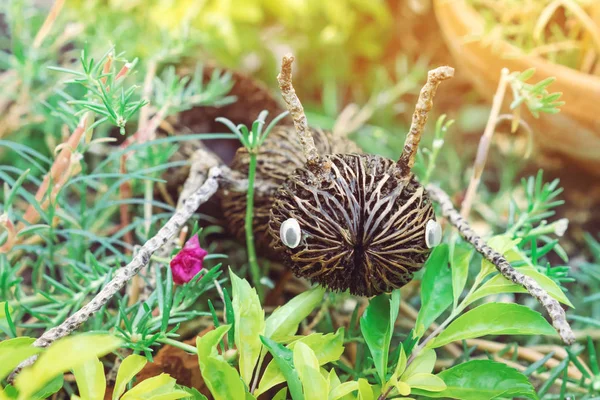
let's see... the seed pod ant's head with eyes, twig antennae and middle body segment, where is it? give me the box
[223,57,453,296]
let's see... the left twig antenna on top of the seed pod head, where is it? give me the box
[277,55,319,164]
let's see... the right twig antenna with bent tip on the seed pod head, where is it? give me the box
[398,66,454,178]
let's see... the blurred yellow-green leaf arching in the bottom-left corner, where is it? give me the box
[15,334,123,399]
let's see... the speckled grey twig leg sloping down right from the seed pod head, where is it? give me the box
[427,185,575,344]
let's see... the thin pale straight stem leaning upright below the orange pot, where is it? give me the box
[460,68,509,218]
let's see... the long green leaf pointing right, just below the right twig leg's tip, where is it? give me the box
[427,303,556,348]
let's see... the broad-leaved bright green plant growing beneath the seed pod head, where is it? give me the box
[172,225,570,400]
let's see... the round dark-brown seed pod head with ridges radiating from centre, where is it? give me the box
[269,154,435,296]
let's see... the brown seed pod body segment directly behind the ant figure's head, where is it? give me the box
[221,125,359,252]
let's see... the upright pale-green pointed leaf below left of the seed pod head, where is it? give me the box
[229,269,265,386]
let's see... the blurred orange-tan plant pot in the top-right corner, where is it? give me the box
[434,0,600,175]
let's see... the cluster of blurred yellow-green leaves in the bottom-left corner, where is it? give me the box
[0,334,196,400]
